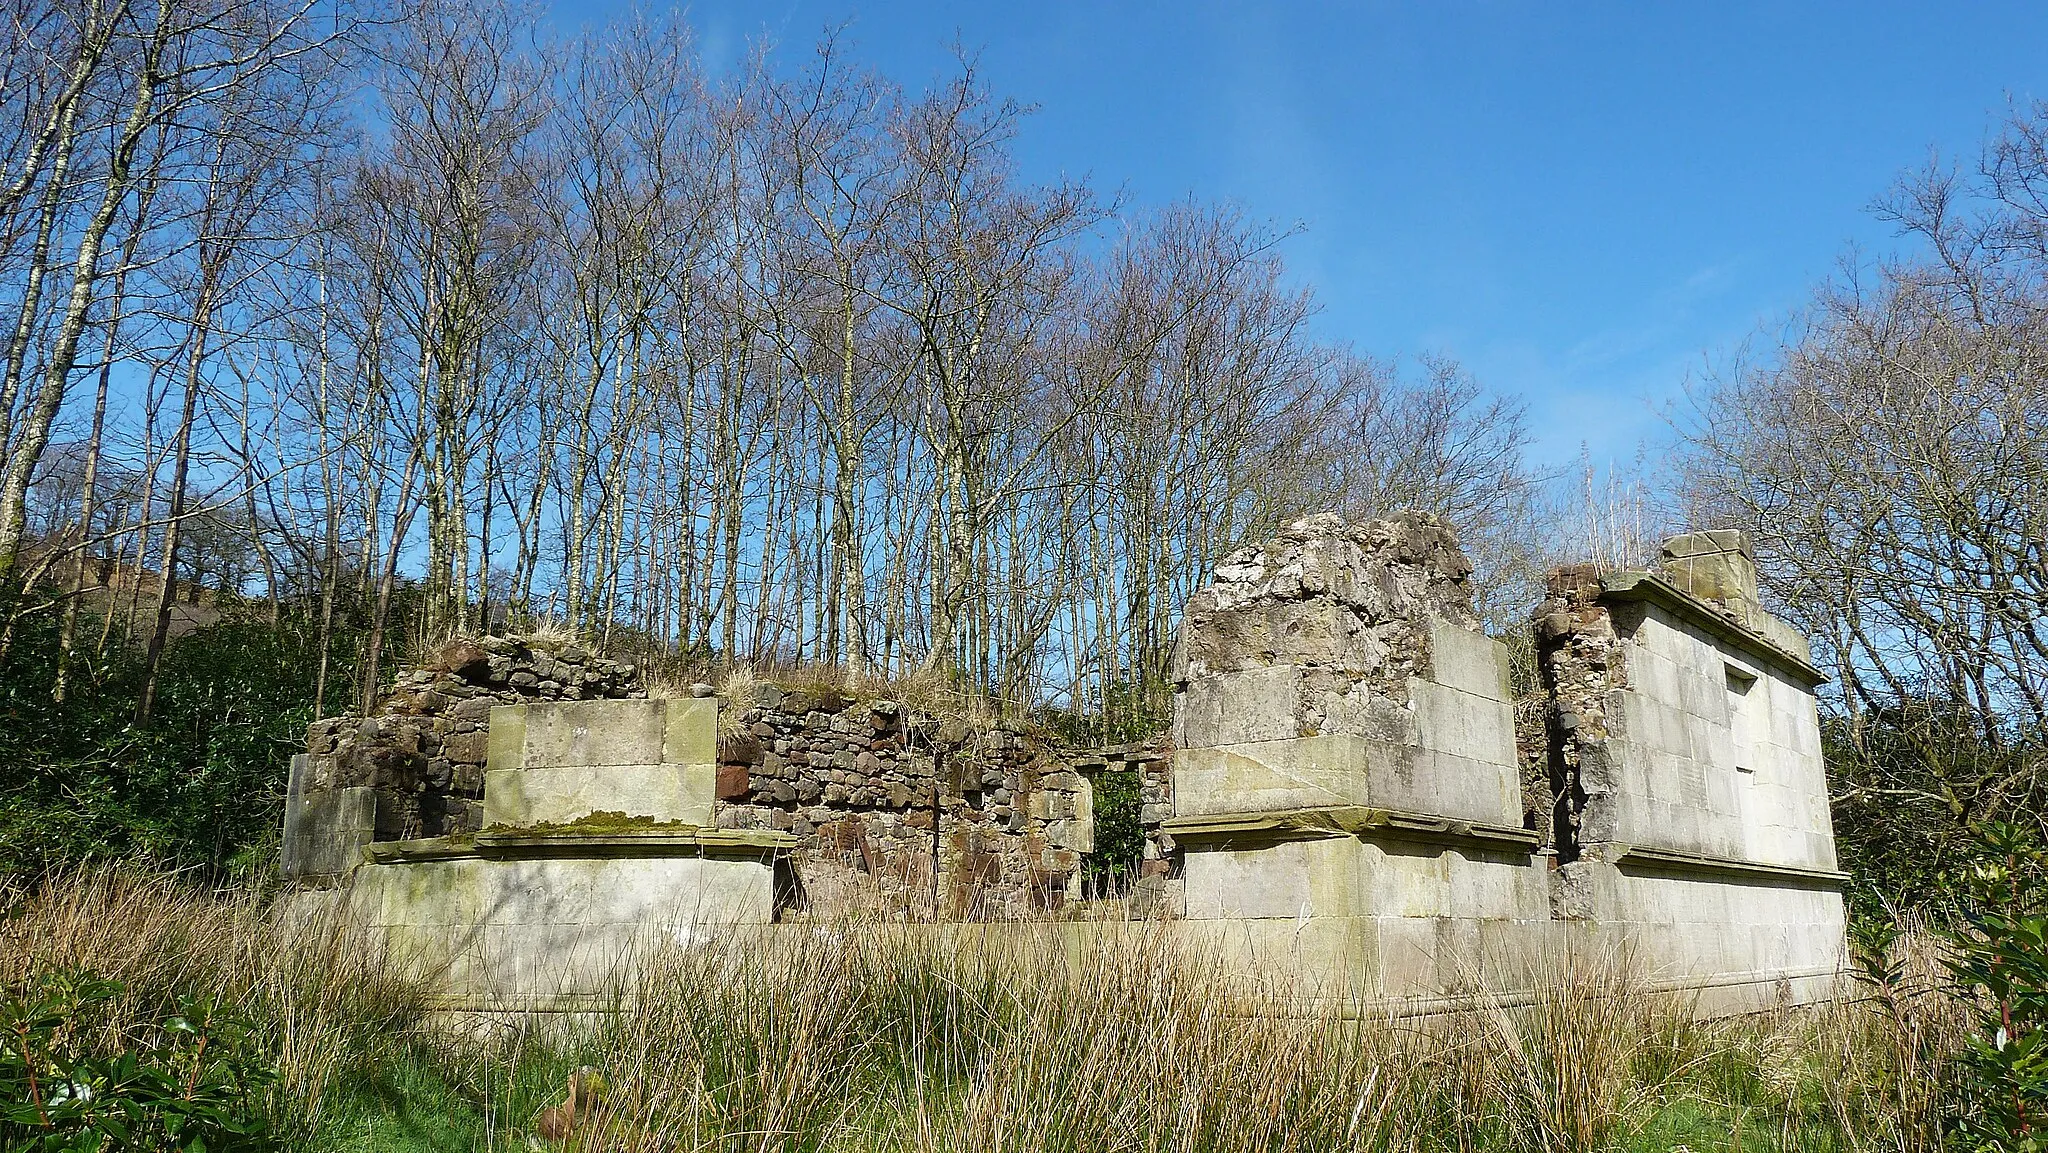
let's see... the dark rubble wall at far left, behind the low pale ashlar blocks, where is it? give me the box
[295,637,647,842]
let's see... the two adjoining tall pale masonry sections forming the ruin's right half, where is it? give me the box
[1163,514,1843,1012]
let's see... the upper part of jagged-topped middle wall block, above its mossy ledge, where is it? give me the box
[1169,512,1522,840]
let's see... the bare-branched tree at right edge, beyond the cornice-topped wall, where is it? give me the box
[1686,106,2048,872]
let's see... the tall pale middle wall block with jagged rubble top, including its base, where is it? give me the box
[1165,514,1548,999]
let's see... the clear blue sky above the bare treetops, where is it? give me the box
[555,0,2048,463]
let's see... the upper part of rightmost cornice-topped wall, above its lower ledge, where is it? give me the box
[1536,530,1833,872]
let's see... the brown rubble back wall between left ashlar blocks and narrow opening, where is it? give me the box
[719,686,1092,917]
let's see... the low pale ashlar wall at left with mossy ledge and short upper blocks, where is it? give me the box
[340,698,795,1010]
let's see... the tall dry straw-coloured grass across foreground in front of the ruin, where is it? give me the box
[0,868,1982,1153]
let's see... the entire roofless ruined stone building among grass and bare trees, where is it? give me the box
[285,514,1843,1012]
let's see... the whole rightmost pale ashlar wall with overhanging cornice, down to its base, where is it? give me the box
[1536,532,1845,1001]
